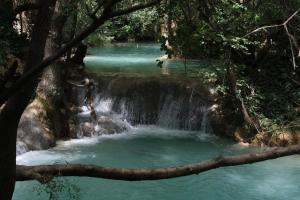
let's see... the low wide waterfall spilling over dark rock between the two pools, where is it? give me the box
[72,77,211,137]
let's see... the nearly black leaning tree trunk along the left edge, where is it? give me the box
[0,0,56,200]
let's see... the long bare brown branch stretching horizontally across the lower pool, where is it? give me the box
[16,145,300,181]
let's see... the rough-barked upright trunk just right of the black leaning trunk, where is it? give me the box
[37,1,69,137]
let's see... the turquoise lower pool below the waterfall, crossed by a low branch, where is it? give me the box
[13,126,300,200]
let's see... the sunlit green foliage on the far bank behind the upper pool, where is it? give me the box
[78,3,159,43]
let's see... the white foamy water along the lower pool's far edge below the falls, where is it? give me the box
[17,126,215,165]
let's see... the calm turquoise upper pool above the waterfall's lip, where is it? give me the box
[84,43,215,75]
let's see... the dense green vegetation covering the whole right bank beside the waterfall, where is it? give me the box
[163,0,300,144]
